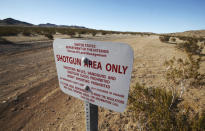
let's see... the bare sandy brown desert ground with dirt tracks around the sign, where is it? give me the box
[0,34,205,131]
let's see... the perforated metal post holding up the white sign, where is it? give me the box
[85,101,98,131]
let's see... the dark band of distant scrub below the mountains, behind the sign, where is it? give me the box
[0,26,154,39]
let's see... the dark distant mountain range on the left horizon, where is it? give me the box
[0,18,86,29]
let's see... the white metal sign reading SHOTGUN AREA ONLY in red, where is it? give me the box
[53,39,133,112]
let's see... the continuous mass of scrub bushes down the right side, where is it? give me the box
[129,35,205,131]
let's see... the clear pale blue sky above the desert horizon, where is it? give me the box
[0,0,205,33]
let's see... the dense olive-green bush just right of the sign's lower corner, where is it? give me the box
[129,84,173,130]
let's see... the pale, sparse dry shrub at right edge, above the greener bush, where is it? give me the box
[165,55,205,91]
